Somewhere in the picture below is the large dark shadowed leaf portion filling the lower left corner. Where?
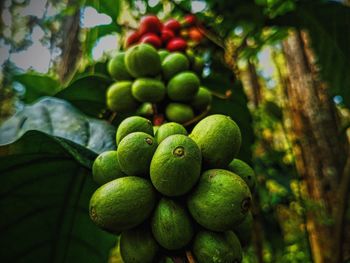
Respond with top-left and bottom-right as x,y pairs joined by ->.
0,131 -> 115,263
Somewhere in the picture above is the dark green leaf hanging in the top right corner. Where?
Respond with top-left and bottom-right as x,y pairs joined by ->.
272,1 -> 350,108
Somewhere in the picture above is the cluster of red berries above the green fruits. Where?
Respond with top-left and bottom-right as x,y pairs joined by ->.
125,15 -> 202,52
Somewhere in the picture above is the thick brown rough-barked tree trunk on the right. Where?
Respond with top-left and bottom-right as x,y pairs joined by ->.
283,31 -> 348,263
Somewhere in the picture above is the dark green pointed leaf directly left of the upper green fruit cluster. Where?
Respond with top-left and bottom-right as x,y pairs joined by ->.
55,74 -> 112,117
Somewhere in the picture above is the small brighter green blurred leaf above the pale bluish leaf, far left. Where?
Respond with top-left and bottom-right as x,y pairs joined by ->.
13,73 -> 61,103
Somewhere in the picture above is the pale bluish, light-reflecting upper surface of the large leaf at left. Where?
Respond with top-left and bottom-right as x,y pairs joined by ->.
0,97 -> 115,153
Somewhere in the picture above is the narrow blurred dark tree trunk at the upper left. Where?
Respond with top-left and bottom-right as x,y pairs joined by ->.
57,0 -> 81,83
